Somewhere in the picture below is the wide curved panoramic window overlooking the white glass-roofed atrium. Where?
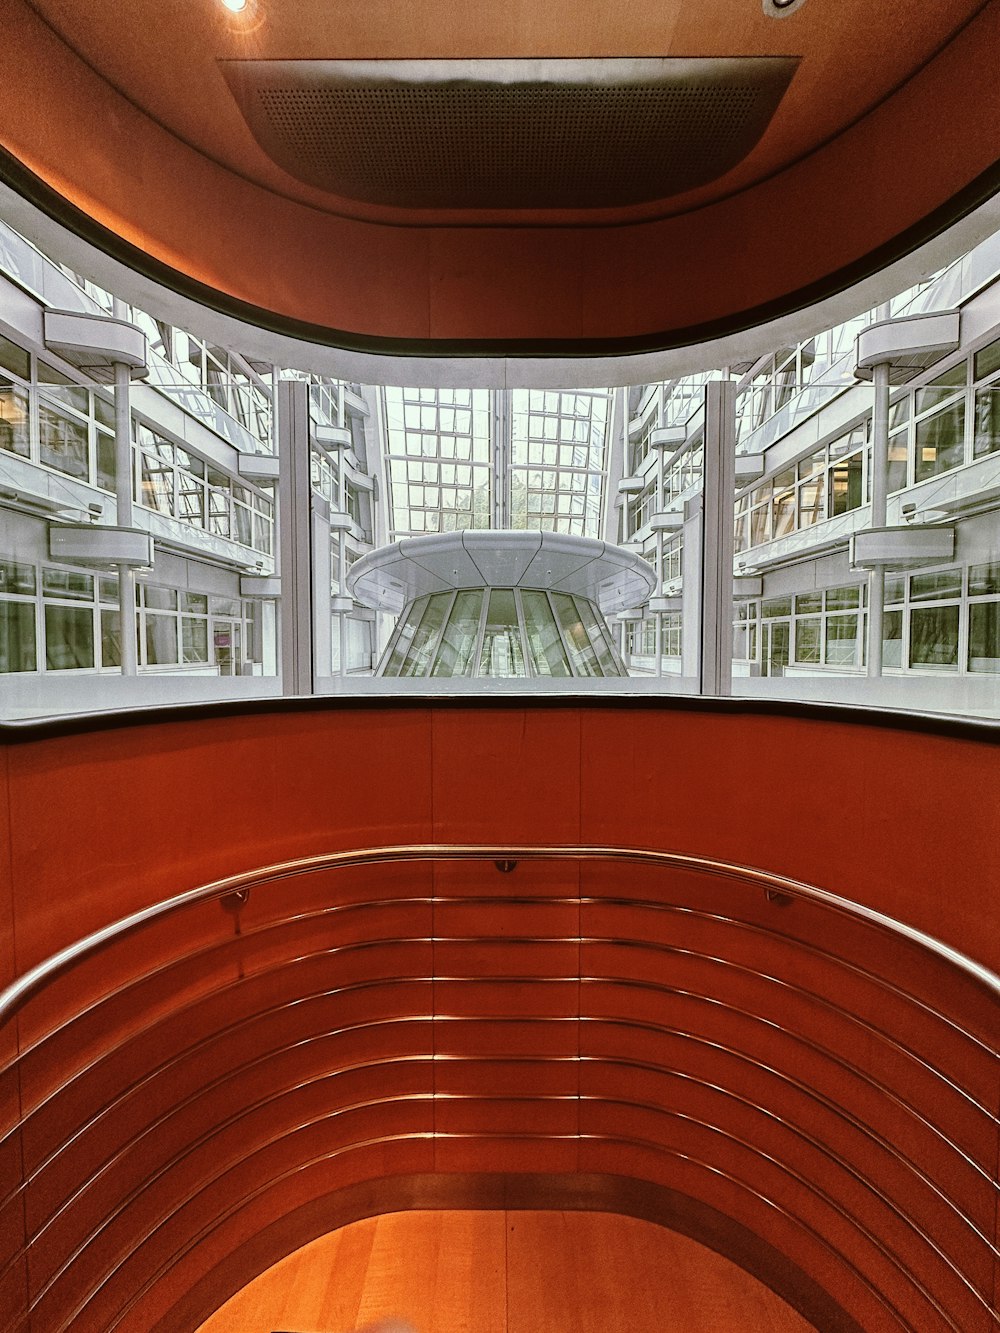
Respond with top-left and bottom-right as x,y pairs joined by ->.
0,210 -> 1000,717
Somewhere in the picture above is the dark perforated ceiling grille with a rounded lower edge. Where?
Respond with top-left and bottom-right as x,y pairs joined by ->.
224,57 -> 796,208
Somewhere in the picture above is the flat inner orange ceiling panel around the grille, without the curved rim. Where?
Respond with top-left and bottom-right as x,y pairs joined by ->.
19,0 -> 983,221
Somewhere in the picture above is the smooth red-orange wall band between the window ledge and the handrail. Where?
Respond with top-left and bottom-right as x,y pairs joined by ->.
5,705 -> 1000,970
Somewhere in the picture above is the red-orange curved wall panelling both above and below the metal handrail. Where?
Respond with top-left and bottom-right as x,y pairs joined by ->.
0,708 -> 1000,1333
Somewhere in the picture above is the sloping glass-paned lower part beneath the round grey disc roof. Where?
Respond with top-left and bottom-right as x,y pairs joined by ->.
376,588 -> 628,680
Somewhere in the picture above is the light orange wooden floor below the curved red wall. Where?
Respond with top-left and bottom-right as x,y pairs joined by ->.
200,1212 -> 812,1333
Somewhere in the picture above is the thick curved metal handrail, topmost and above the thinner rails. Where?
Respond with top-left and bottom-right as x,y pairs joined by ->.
0,842 -> 1000,1026
